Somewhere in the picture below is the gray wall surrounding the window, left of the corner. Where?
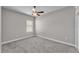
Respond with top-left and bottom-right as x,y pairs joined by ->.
2,8 -> 34,41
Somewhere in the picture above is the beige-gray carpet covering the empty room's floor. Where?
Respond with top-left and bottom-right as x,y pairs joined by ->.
2,37 -> 78,53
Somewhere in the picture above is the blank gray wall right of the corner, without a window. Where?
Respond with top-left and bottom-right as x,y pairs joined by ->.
36,7 -> 75,44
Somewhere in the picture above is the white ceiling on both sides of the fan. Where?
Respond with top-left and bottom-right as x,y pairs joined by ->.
4,6 -> 67,15
